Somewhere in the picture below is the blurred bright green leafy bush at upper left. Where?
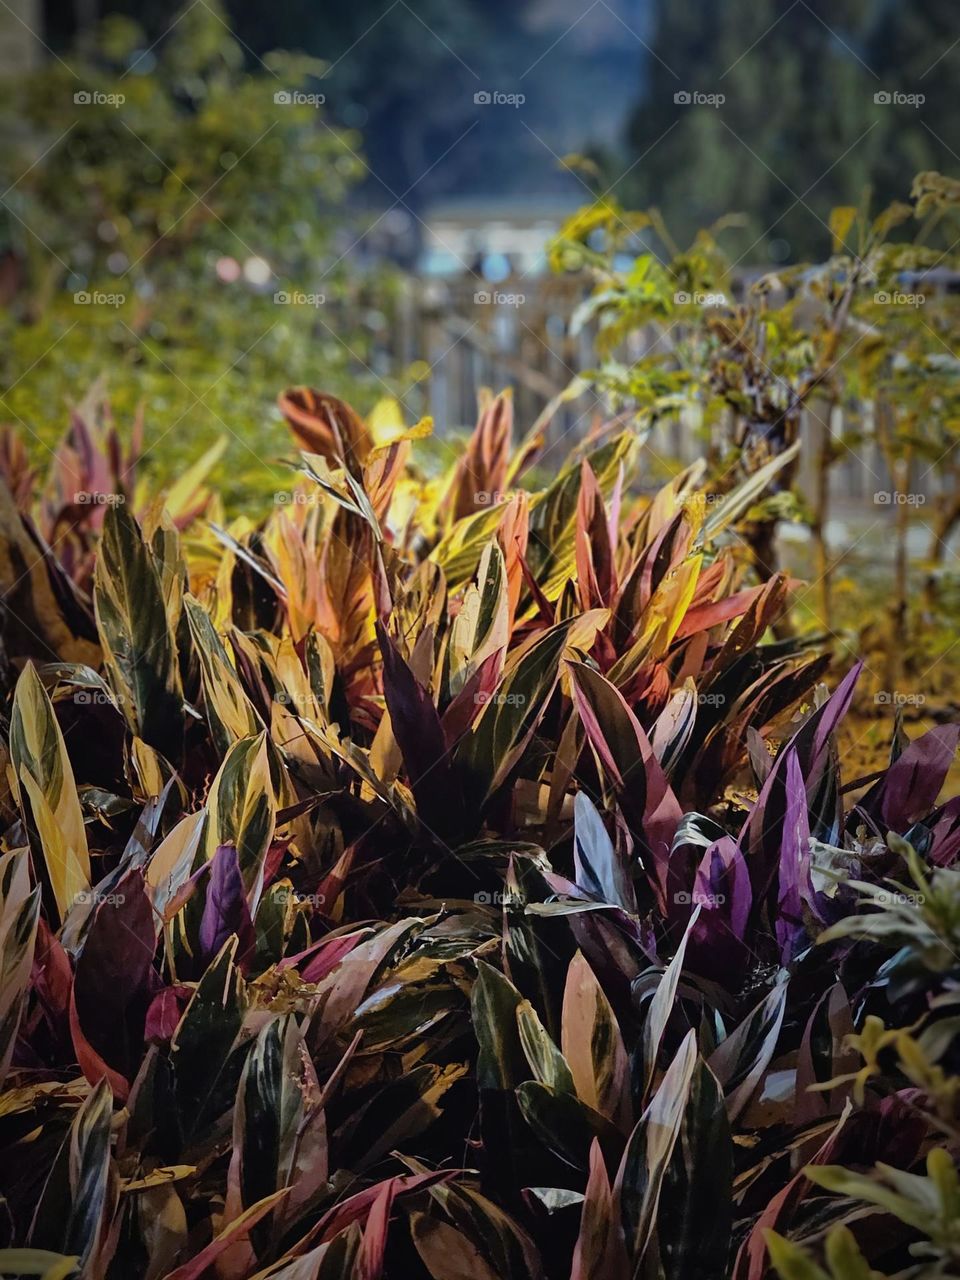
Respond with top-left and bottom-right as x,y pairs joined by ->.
0,3 -> 384,506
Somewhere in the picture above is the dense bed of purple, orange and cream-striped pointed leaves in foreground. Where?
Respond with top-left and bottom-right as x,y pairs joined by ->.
0,388 -> 960,1280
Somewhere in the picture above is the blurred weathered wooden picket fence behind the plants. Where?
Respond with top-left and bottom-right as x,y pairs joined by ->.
355,276 -> 952,515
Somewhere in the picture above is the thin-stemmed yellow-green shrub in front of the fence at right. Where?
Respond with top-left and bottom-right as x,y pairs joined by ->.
552,173 -> 960,687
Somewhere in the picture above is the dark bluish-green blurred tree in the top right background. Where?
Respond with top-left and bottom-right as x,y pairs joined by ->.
619,0 -> 960,264
